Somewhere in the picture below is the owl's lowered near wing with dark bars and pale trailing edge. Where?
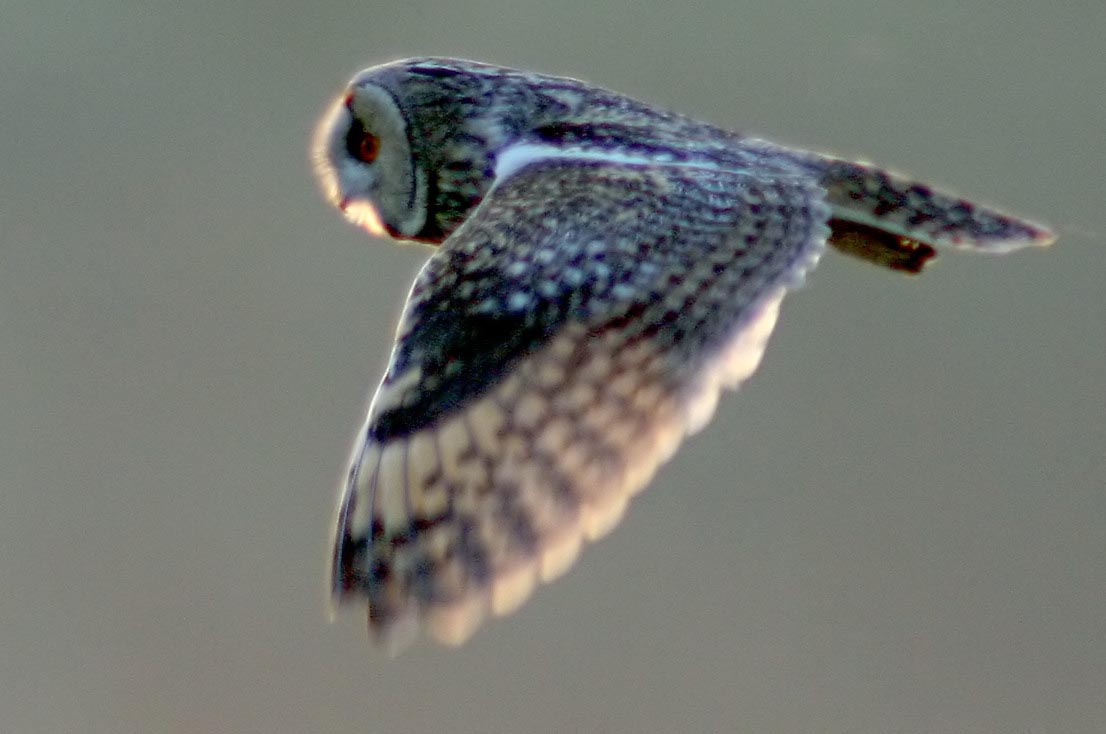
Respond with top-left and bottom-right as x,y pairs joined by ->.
333,159 -> 830,646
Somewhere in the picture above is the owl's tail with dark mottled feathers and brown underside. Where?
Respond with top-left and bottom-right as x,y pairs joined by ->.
803,157 -> 1056,273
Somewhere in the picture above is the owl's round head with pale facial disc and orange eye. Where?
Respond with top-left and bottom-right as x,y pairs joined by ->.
314,59 -> 557,242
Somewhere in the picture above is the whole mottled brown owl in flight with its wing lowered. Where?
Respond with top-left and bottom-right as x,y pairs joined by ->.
314,57 -> 1053,649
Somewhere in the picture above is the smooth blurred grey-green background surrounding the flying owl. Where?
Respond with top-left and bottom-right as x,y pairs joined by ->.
0,0 -> 1106,734
